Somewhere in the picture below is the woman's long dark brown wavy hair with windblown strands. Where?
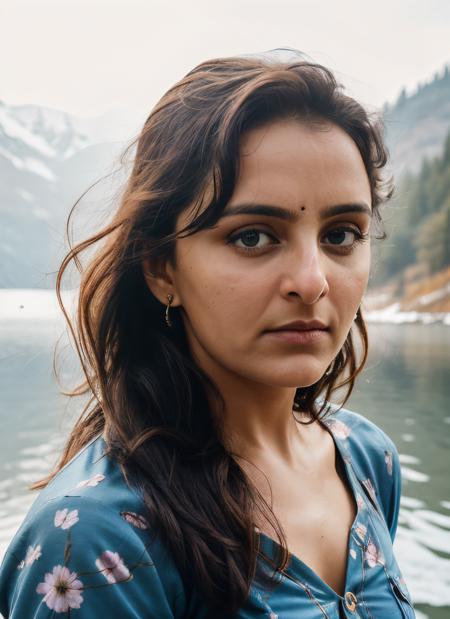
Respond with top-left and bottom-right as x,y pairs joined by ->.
33,51 -> 392,617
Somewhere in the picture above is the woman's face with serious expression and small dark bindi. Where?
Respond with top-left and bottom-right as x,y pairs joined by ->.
163,119 -> 371,387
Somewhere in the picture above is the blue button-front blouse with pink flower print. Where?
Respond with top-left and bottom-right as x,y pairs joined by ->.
0,409 -> 415,619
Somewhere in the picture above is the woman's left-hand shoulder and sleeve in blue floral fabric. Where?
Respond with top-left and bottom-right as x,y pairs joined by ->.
0,437 -> 192,619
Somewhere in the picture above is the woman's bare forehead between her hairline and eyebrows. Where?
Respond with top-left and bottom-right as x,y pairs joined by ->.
177,119 -> 371,230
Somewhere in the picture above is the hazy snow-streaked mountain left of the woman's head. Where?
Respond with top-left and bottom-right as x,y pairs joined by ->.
0,102 -> 142,288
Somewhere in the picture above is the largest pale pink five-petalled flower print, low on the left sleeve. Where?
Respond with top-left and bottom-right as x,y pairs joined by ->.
36,565 -> 83,613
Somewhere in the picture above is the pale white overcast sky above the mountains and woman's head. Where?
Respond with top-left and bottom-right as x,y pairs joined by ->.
0,0 -> 450,116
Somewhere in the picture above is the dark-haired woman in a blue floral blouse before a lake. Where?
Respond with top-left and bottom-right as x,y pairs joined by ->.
0,50 -> 414,619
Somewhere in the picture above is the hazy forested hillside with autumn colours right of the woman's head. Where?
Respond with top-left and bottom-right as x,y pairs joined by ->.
366,66 -> 450,313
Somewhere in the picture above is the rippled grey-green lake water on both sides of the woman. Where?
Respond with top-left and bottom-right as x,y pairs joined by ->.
0,319 -> 450,619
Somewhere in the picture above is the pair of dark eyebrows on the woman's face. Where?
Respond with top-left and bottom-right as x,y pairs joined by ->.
222,202 -> 372,223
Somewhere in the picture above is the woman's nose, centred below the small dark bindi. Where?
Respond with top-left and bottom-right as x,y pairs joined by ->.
282,247 -> 329,305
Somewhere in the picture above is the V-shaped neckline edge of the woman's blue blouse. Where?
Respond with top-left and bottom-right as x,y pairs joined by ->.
259,419 -> 363,600
